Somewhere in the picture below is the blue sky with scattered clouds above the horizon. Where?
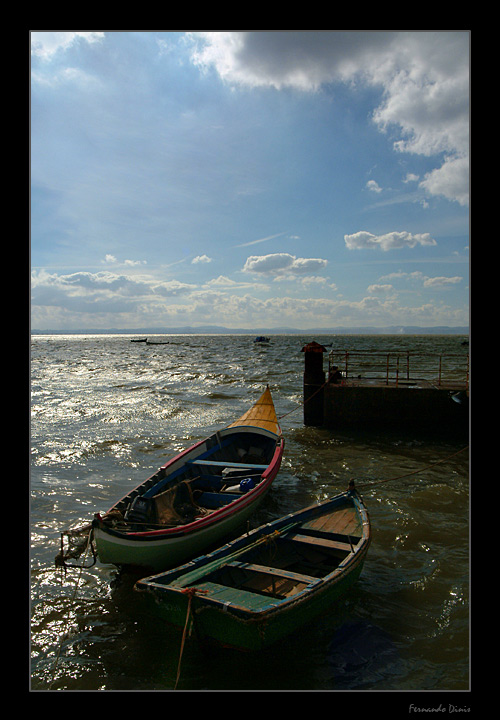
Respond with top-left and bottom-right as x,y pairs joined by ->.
30,30 -> 470,332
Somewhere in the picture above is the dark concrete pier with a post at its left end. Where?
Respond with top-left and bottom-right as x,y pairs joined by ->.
302,342 -> 469,435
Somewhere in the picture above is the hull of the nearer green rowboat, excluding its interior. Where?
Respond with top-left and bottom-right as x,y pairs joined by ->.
135,493 -> 370,651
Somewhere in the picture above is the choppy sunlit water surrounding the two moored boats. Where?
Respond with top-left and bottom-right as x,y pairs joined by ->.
31,335 -> 469,702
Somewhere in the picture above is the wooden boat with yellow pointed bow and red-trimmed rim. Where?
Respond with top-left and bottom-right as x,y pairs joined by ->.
56,387 -> 284,572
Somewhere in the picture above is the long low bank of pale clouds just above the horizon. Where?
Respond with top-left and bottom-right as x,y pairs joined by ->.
32,270 -> 468,330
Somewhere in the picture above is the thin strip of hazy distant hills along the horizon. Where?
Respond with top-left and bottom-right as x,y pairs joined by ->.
31,325 -> 469,335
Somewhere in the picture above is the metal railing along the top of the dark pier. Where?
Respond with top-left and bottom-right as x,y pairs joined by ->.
329,350 -> 469,389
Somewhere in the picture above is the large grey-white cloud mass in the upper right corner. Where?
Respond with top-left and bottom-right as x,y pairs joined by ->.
187,30 -> 469,205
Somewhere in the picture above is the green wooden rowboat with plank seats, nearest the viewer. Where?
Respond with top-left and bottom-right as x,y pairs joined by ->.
135,486 -> 371,650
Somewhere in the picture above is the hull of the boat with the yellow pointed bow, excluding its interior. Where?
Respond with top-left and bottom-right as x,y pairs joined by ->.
87,388 -> 284,572
